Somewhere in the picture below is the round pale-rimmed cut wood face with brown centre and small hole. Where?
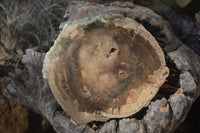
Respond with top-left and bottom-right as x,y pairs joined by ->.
43,16 -> 169,123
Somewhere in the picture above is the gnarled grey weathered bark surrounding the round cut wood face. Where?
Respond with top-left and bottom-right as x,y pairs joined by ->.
0,2 -> 200,133
